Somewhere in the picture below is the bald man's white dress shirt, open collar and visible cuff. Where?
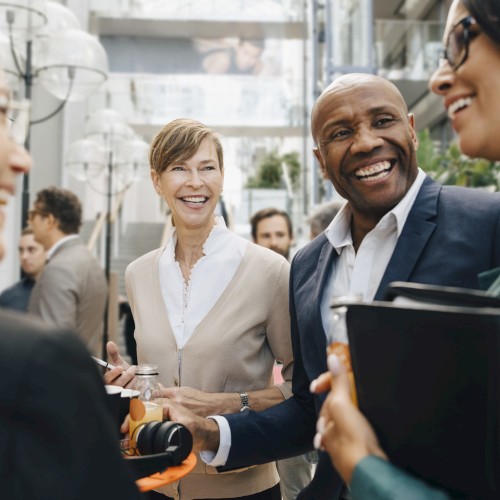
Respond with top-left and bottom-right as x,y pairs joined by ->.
204,168 -> 425,467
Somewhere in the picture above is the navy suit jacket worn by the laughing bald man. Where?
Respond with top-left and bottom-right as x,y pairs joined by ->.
221,177 -> 500,500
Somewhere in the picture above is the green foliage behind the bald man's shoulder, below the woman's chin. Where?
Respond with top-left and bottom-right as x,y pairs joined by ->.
417,129 -> 500,191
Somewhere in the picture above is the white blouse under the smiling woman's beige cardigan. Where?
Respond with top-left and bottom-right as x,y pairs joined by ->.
159,216 -> 248,349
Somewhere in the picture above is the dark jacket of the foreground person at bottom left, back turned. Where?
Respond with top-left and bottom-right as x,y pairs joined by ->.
0,310 -> 142,500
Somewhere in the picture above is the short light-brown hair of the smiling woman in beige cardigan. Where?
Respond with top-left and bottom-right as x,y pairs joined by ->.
149,118 -> 224,174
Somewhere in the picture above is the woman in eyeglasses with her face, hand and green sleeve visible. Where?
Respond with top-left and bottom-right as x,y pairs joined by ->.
311,0 -> 500,500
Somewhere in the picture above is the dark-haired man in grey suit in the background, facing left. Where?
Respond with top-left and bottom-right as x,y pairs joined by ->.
28,187 -> 107,356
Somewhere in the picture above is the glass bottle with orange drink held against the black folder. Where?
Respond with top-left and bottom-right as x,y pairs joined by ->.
326,294 -> 363,406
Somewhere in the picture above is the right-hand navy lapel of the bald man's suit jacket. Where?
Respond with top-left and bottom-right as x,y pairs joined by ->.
375,177 -> 442,300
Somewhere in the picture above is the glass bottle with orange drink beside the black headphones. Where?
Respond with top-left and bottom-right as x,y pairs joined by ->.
130,365 -> 163,448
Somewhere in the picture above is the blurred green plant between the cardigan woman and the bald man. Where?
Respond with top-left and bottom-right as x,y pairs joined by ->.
247,151 -> 300,189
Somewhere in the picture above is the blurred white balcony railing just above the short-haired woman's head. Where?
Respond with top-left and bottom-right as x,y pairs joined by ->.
88,73 -> 303,127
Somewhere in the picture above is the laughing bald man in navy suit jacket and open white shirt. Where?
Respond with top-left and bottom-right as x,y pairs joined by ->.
118,74 -> 500,500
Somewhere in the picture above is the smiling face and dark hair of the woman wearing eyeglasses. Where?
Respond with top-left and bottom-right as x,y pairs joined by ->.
430,0 -> 500,161
